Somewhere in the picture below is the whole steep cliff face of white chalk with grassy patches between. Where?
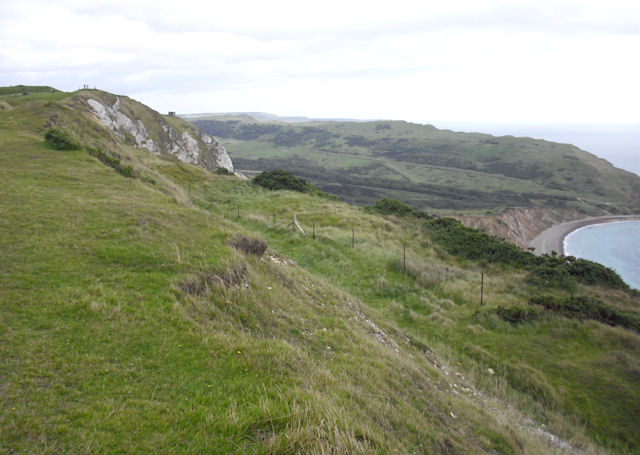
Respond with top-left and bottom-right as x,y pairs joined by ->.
86,94 -> 233,172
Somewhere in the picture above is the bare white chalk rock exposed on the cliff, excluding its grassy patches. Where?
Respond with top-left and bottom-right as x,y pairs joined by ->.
87,97 -> 233,172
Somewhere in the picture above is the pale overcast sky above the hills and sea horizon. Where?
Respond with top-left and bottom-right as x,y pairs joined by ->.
0,0 -> 640,123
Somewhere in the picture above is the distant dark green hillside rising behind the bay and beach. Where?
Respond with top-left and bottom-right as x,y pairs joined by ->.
194,116 -> 640,214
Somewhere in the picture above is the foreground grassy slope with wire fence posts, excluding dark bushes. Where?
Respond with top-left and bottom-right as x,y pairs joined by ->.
0,87 -> 640,453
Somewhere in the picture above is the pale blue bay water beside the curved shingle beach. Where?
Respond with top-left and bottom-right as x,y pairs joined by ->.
564,221 -> 640,289
